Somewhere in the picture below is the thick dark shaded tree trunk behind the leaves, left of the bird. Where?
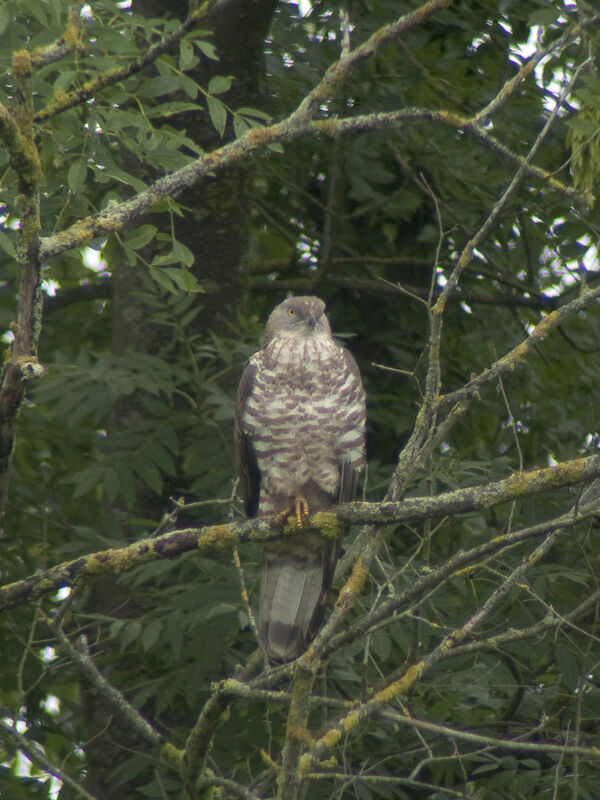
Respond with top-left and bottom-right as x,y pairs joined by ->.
81,0 -> 276,800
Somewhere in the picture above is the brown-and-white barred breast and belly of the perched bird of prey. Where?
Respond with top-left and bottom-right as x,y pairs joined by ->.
242,337 -> 365,514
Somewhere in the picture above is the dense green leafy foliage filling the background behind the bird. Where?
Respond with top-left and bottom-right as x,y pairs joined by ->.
0,0 -> 600,800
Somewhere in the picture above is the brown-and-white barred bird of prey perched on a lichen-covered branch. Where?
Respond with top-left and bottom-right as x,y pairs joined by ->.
235,297 -> 365,663
